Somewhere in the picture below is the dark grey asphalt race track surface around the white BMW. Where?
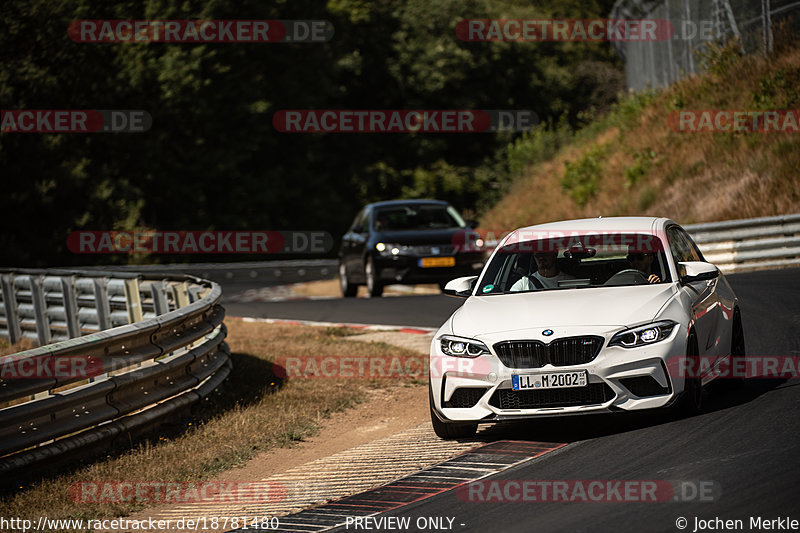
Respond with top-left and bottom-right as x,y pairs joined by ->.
228,269 -> 800,532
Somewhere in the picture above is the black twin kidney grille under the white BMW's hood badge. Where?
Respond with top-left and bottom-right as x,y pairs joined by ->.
494,336 -> 603,368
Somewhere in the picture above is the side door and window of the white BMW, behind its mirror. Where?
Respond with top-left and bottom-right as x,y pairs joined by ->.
667,226 -> 720,364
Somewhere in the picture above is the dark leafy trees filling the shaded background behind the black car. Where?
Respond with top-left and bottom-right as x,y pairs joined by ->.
0,0 -> 621,266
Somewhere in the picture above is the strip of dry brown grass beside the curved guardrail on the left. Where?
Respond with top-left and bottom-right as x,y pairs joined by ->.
0,319 -> 422,519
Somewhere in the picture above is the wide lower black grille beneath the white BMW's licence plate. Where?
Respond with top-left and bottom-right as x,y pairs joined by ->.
489,383 -> 614,409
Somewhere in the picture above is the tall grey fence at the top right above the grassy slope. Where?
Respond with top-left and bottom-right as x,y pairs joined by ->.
610,0 -> 800,91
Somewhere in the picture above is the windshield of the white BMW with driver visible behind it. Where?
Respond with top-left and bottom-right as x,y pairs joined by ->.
477,233 -> 670,295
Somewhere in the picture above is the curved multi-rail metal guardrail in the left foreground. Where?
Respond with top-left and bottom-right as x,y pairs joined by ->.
0,270 -> 232,474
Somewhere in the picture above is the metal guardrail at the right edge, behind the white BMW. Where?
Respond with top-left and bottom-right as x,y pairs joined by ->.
684,214 -> 800,272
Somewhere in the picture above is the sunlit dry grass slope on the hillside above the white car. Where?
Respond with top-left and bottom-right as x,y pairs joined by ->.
481,42 -> 800,232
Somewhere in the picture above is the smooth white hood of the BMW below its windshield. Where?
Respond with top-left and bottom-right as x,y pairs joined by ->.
451,284 -> 675,337
